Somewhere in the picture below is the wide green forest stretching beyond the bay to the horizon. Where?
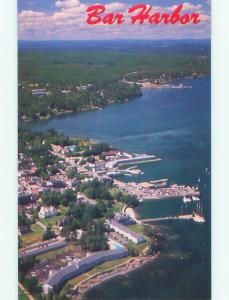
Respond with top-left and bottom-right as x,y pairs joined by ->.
18,45 -> 210,120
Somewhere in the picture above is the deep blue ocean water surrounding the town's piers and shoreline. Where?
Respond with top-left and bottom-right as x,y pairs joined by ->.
29,78 -> 211,299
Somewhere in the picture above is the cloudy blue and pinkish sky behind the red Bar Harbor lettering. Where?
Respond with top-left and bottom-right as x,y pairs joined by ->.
18,0 -> 211,40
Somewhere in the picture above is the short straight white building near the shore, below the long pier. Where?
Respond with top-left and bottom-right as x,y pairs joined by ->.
108,219 -> 145,244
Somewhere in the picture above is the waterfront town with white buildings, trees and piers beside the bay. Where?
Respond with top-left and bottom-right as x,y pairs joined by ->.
18,129 -> 204,299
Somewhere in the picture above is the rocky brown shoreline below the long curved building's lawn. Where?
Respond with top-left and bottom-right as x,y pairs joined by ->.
73,254 -> 159,300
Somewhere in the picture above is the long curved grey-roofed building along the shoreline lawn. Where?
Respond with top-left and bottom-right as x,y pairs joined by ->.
43,247 -> 128,294
